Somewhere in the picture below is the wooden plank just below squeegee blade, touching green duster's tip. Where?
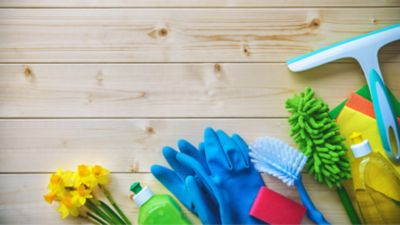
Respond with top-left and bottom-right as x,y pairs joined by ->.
0,63 -> 400,118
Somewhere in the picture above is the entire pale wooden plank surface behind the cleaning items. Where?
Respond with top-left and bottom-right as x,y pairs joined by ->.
0,0 -> 400,224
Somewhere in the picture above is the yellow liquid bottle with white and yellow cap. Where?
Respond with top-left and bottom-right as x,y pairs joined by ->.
351,132 -> 400,224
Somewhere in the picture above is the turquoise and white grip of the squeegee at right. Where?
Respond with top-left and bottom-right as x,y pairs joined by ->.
367,69 -> 400,163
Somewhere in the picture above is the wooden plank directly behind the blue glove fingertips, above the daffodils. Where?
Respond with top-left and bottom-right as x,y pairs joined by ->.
0,119 -> 291,173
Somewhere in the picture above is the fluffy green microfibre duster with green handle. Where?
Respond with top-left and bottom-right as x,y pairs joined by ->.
286,88 -> 361,224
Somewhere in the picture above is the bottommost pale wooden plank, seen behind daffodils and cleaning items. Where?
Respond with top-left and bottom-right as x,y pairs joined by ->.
0,174 -> 350,224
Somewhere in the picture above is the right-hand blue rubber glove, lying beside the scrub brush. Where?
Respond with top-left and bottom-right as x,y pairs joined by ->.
176,128 -> 264,224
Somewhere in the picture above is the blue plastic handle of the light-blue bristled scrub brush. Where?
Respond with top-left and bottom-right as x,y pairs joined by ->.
294,176 -> 330,225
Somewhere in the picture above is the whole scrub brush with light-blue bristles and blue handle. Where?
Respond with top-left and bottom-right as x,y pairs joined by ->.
249,137 -> 329,224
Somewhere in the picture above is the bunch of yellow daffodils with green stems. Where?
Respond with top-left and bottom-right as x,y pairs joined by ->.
43,165 -> 132,225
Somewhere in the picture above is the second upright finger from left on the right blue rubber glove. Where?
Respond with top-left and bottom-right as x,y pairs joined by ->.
217,130 -> 247,170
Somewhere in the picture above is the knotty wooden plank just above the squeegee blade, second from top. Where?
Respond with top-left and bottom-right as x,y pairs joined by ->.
0,7 -> 400,63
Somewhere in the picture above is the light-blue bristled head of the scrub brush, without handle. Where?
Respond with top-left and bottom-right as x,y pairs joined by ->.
249,137 -> 307,186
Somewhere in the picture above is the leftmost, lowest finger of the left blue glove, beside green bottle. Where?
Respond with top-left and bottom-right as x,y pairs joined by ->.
150,165 -> 194,211
